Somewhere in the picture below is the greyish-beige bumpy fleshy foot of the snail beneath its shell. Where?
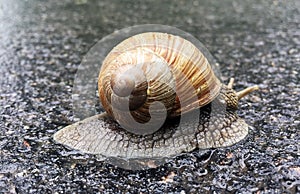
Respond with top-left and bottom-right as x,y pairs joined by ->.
54,86 -> 248,159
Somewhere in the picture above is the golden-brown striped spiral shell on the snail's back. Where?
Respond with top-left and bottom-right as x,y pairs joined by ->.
98,32 -> 221,133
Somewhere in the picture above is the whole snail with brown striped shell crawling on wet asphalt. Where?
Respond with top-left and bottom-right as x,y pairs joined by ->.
54,32 -> 258,169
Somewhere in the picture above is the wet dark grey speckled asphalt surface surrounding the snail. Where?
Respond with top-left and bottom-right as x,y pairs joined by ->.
0,0 -> 300,193
